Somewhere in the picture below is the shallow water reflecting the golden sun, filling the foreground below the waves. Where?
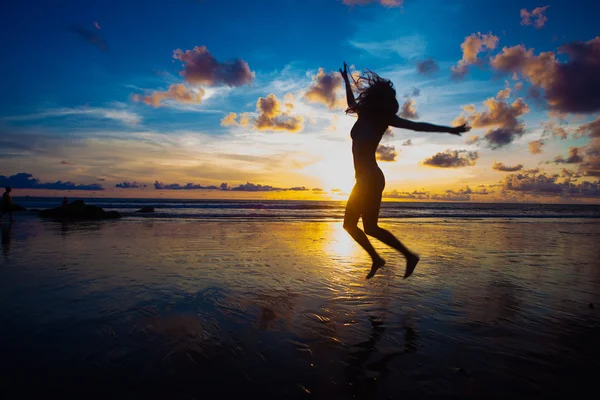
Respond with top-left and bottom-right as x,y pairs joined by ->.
0,218 -> 600,399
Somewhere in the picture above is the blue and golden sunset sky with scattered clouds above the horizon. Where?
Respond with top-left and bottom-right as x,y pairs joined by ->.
0,0 -> 600,203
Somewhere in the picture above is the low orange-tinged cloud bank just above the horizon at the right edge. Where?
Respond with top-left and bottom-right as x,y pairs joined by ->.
501,172 -> 600,198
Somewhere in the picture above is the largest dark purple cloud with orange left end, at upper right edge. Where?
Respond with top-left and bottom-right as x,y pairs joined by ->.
491,37 -> 600,113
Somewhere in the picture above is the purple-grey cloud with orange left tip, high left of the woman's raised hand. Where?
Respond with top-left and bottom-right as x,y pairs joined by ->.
173,46 -> 255,87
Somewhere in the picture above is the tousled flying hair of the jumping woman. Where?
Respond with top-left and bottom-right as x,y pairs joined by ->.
346,69 -> 400,115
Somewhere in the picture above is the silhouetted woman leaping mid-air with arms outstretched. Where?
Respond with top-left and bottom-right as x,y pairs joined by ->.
340,62 -> 471,279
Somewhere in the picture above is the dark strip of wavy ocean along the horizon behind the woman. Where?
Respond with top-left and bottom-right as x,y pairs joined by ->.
14,197 -> 600,220
